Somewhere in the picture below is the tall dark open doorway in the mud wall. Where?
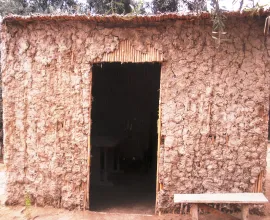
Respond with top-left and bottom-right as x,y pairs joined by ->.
89,63 -> 161,214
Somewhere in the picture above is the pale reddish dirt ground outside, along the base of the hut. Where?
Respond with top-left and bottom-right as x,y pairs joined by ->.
0,144 -> 270,220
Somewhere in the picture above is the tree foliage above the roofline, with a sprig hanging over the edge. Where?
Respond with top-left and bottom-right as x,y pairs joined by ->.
0,0 -> 269,16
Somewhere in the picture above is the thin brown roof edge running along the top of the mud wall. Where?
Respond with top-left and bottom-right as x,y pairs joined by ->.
3,10 -> 270,24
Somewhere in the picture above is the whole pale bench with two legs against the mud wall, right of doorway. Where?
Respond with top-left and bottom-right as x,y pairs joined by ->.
174,193 -> 268,220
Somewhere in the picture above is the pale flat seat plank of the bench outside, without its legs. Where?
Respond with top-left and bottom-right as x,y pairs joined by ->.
174,193 -> 268,204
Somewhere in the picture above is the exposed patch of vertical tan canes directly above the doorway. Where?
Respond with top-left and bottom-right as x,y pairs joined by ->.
94,40 -> 163,63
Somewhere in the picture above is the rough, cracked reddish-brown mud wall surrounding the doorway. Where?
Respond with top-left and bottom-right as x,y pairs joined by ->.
1,14 -> 270,212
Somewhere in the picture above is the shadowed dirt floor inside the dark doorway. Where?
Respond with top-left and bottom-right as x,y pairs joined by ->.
90,173 -> 156,215
